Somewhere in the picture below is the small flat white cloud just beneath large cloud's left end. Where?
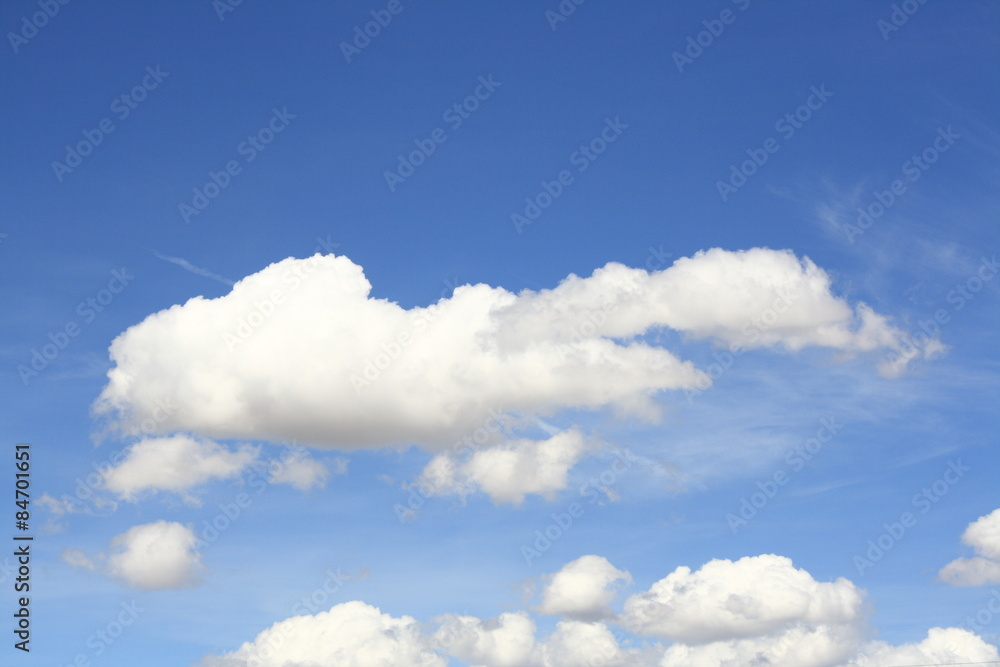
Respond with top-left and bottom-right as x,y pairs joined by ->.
105,435 -> 259,501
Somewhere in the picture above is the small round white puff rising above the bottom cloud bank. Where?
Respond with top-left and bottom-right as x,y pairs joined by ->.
539,556 -> 632,620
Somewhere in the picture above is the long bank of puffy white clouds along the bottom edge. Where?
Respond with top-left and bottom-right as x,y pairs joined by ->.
202,555 -> 998,667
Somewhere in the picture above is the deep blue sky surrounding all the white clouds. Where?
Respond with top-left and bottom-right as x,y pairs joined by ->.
0,0 -> 1000,666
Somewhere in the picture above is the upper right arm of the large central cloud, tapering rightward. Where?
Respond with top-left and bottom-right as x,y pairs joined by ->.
501,248 -> 902,350
